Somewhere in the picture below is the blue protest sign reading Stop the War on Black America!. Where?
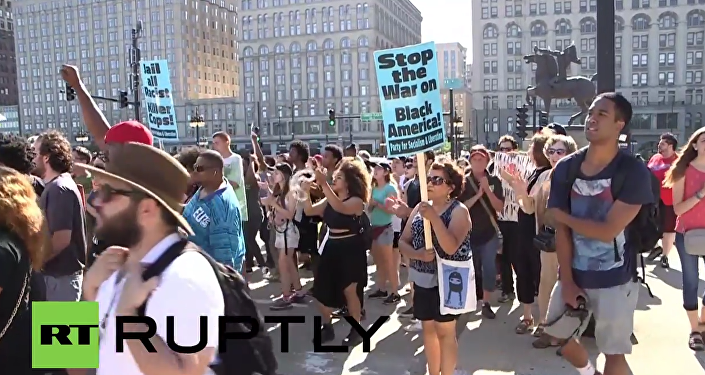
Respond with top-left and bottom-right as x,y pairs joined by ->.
374,42 -> 446,157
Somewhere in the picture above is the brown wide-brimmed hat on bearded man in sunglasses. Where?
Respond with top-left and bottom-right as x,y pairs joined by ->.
76,142 -> 193,235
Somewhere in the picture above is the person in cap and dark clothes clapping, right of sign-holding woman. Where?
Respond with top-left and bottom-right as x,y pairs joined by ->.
458,145 -> 504,319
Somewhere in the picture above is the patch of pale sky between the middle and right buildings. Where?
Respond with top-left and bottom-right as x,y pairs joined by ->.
411,0 -> 479,62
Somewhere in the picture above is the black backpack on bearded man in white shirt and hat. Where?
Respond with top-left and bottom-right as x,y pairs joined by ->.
138,240 -> 277,375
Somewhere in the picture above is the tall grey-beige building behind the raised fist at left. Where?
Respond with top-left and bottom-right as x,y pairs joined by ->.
14,0 -> 240,140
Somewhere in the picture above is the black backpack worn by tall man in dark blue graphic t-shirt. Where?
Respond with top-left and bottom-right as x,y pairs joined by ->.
567,147 -> 663,297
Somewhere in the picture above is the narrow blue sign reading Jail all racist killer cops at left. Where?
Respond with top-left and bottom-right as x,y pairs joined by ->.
140,60 -> 179,141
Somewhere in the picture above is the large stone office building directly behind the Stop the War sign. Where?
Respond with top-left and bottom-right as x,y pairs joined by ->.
239,0 -> 421,153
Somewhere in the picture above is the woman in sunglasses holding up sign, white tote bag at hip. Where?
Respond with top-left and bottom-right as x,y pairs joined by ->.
399,162 -> 475,375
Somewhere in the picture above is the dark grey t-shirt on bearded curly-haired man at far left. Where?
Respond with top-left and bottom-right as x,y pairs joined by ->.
39,173 -> 86,276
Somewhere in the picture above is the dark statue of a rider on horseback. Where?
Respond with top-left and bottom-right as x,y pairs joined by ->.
524,44 -> 597,125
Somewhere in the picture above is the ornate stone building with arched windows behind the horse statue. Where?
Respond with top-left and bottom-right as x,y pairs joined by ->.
472,0 -> 705,149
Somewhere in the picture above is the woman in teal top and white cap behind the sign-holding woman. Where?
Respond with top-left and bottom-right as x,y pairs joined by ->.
367,162 -> 401,305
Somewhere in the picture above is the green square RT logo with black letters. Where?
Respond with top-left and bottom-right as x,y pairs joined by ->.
32,302 -> 100,369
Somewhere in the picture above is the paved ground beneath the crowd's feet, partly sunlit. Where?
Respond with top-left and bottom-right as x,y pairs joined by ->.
251,254 -> 705,375
